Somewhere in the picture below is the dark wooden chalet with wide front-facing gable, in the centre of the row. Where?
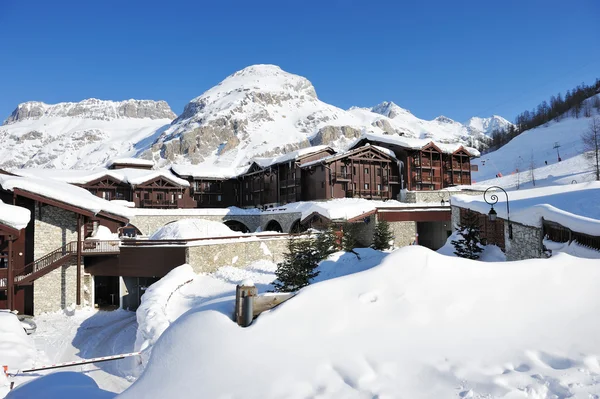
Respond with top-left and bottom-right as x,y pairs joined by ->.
302,144 -> 400,201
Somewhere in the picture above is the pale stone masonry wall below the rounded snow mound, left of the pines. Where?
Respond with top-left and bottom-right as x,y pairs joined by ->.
187,238 -> 288,273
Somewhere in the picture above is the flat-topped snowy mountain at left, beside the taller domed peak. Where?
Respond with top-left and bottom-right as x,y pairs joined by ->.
0,99 -> 176,169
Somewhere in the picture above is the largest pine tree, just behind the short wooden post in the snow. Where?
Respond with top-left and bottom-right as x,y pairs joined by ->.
273,238 -> 321,292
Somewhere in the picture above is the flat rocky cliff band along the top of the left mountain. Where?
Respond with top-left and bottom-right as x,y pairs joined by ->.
4,98 -> 177,125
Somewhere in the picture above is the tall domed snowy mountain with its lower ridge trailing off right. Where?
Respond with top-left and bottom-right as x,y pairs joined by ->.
143,65 -> 508,166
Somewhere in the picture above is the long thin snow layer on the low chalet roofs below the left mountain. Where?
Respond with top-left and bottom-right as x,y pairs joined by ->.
12,168 -> 190,187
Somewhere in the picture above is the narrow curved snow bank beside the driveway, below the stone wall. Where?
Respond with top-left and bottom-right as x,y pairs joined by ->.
135,265 -> 196,370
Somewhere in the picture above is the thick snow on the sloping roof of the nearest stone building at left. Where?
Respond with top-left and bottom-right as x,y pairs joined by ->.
0,174 -> 129,217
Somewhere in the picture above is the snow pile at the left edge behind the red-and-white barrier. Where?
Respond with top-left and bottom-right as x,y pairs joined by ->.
0,310 -> 36,397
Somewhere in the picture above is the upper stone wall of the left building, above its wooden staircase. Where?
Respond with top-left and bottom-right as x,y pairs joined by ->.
33,205 -> 77,259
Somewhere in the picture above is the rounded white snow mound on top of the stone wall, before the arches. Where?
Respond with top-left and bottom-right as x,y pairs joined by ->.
150,219 -> 240,240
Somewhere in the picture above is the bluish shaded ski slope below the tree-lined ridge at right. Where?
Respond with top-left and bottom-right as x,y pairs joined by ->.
472,95 -> 597,188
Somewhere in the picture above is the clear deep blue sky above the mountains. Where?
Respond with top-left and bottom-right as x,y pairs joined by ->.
0,0 -> 600,122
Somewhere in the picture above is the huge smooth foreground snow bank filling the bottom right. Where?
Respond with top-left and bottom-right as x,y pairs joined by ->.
122,246 -> 600,398
